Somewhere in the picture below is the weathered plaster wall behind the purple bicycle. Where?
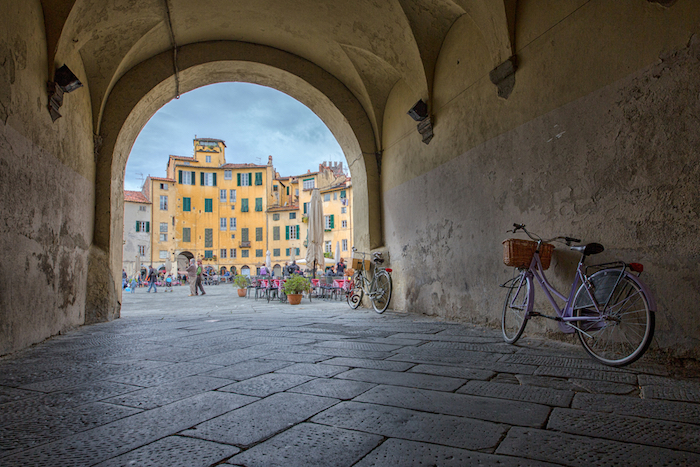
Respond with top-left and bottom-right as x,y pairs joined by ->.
382,1 -> 700,358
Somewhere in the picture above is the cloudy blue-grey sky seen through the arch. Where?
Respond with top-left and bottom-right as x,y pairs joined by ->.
124,83 -> 347,191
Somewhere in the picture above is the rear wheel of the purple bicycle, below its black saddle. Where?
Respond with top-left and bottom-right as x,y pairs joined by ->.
574,270 -> 655,366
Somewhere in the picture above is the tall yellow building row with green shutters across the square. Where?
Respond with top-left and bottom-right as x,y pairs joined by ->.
145,138 -> 352,275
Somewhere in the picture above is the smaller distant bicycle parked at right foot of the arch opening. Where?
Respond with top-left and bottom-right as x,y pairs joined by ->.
346,247 -> 392,313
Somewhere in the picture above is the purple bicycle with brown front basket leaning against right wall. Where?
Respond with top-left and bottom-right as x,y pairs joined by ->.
501,224 -> 656,366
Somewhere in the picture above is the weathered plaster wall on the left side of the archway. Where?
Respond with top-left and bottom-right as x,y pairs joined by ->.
0,1 -> 94,355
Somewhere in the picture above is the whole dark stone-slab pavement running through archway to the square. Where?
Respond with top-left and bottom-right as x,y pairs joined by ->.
0,285 -> 700,467
